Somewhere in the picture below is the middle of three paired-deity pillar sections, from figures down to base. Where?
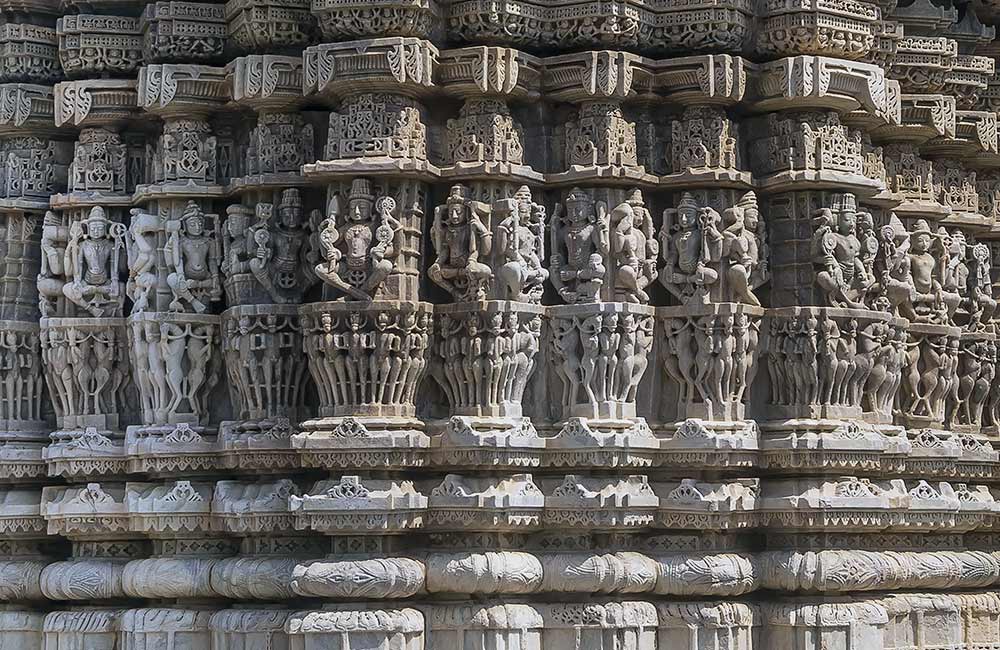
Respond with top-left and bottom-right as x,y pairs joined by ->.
546,188 -> 659,465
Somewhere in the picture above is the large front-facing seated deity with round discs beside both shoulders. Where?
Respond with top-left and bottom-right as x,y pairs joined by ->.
315,178 -> 403,301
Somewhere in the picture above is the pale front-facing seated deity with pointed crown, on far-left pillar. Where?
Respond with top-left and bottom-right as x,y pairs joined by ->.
63,206 -> 125,318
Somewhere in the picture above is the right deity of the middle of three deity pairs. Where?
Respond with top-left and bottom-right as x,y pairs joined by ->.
609,190 -> 660,304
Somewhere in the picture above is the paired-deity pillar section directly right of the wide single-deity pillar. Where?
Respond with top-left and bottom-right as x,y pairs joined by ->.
429,185 -> 548,465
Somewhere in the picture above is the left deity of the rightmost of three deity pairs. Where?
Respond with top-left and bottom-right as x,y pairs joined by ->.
660,192 -> 724,305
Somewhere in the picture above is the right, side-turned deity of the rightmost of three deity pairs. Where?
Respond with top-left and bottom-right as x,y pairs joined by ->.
722,192 -> 768,307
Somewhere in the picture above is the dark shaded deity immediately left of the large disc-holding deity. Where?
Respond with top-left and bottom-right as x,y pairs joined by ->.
247,188 -> 313,304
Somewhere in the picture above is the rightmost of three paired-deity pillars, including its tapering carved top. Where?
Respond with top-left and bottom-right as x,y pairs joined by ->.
653,71 -> 770,454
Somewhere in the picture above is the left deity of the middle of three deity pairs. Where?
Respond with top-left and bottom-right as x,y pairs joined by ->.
549,187 -> 611,304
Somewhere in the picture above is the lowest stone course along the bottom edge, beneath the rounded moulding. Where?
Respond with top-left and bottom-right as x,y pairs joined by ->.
0,591 -> 1000,650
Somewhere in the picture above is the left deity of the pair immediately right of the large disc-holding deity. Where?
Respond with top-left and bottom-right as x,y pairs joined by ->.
427,185 -> 493,301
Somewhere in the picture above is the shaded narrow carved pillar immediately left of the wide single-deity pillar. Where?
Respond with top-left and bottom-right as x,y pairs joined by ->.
219,55 -> 322,469
